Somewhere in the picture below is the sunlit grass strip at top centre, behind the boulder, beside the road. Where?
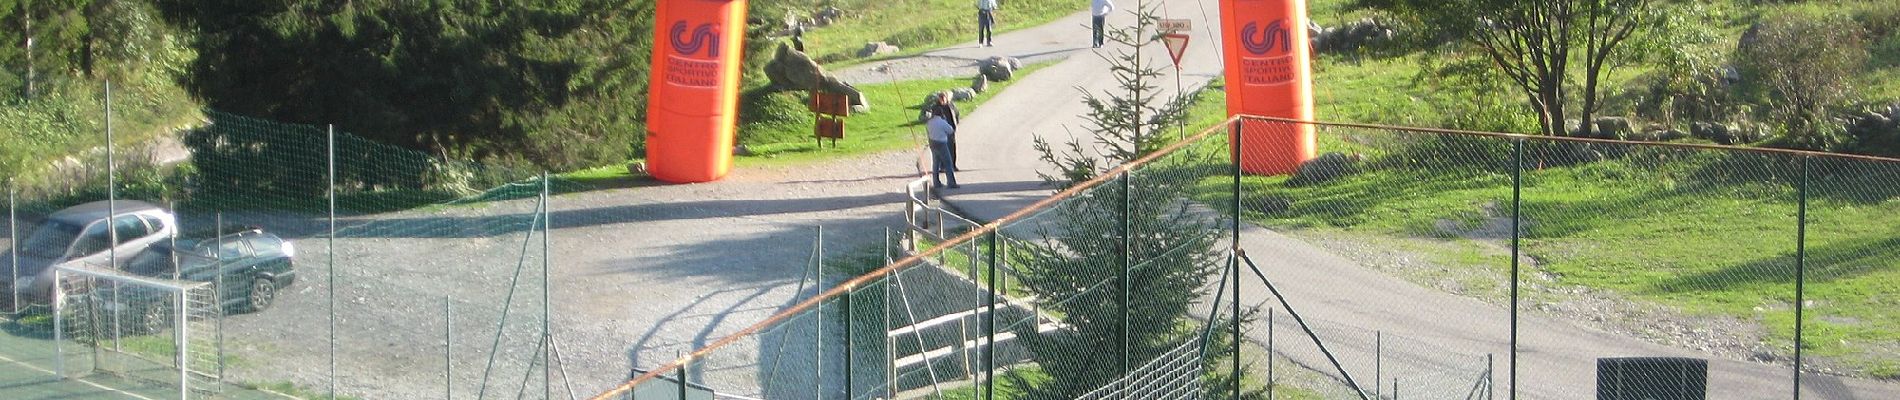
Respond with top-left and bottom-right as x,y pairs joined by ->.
806,0 -> 1094,68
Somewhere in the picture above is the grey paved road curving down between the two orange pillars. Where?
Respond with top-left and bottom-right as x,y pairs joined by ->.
866,0 -> 1900,398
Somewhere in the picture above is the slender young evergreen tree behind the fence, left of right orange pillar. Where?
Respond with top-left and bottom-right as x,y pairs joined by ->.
1018,8 -> 1224,398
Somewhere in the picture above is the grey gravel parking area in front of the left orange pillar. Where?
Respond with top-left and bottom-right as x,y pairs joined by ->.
194,152 -> 916,398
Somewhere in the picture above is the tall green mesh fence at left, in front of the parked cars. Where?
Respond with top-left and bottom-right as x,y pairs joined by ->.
0,82 -> 566,398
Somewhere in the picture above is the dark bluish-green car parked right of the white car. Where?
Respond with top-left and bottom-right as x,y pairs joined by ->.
95,227 -> 296,334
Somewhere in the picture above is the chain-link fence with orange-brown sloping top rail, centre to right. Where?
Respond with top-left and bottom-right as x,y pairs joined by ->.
585,114 -> 1900,398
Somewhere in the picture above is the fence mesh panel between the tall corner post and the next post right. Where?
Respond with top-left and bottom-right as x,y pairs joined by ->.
1239,119 -> 1514,398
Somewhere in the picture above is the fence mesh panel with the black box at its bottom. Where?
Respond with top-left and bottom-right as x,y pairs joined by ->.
1518,140 -> 1799,398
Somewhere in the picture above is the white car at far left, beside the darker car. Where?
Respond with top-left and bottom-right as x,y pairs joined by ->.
0,201 -> 179,303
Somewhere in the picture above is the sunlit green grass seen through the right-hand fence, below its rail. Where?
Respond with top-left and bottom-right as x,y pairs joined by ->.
1203,140 -> 1900,375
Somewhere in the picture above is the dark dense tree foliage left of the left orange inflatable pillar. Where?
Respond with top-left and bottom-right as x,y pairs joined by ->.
158,0 -> 654,169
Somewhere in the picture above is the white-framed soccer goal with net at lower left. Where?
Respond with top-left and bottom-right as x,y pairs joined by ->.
53,265 -> 224,398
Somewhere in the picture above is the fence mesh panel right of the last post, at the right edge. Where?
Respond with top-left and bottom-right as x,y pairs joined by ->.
1782,155 -> 1900,398
